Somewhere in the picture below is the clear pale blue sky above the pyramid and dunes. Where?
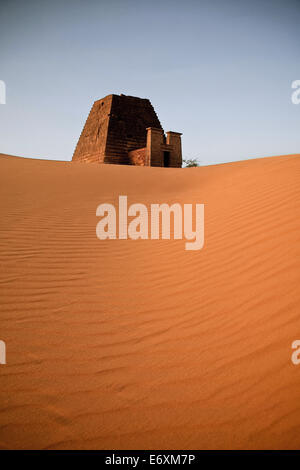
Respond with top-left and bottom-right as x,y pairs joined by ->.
0,0 -> 300,165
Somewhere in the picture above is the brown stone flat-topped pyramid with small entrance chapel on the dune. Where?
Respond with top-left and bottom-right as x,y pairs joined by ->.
72,95 -> 182,168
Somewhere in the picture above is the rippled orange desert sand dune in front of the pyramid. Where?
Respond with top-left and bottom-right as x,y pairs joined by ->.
0,155 -> 300,449
